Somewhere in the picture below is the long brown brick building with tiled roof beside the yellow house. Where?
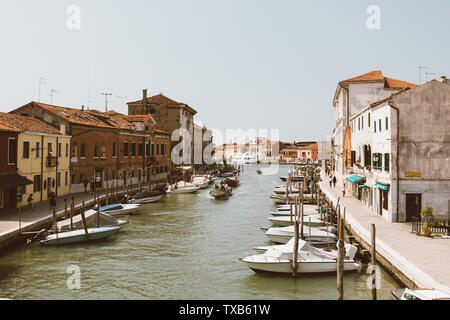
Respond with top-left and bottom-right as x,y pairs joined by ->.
11,102 -> 154,192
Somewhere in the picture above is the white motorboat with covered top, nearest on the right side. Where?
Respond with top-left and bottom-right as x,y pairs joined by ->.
239,239 -> 359,274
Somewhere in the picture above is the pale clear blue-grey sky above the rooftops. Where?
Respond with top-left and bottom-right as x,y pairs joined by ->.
0,0 -> 450,141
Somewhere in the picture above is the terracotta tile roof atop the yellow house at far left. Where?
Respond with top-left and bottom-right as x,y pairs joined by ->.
0,112 -> 60,134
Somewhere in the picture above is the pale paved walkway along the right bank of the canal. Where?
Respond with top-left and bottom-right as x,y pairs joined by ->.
320,176 -> 450,294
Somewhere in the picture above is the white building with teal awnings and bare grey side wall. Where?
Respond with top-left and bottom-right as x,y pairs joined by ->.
346,78 -> 450,222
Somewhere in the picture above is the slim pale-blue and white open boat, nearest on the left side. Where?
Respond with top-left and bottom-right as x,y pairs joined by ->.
40,227 -> 120,246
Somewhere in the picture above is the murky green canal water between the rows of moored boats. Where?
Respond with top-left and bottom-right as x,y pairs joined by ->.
0,166 -> 398,300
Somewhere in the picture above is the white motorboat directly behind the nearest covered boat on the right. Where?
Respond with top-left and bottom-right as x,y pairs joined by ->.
262,226 -> 337,246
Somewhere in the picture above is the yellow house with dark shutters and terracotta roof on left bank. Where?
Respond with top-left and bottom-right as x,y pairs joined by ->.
0,114 -> 71,206
